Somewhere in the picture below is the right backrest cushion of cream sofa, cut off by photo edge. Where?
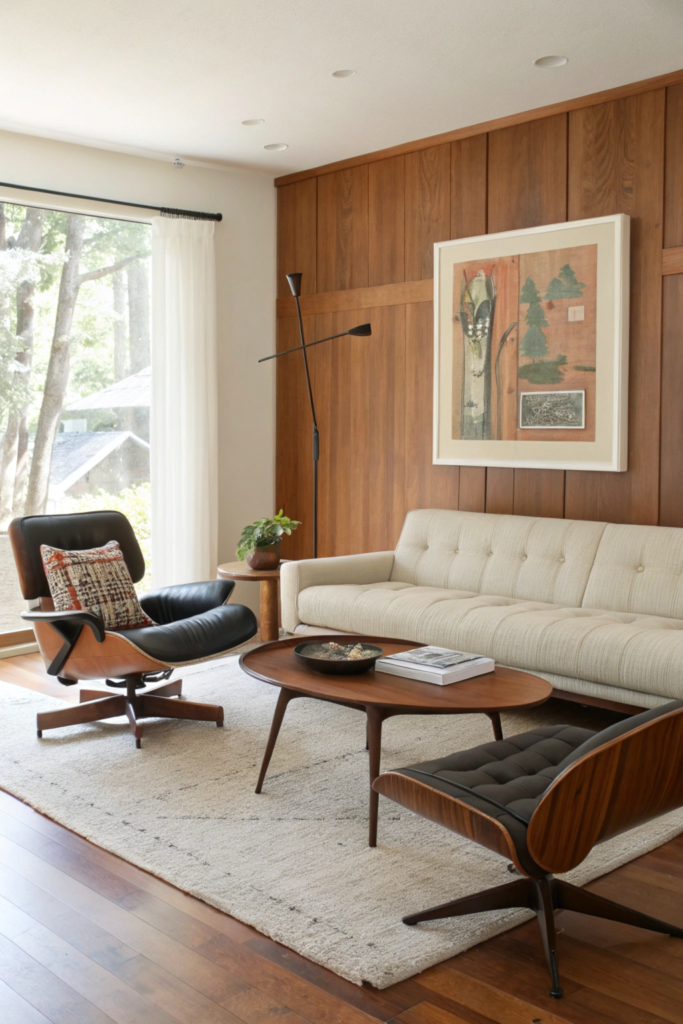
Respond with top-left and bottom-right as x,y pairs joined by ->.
582,523 -> 683,618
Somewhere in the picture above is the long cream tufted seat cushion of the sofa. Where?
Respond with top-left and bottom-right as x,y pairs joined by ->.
298,582 -> 683,702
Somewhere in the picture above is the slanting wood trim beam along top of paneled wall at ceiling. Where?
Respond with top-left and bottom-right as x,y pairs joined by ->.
274,69 -> 683,188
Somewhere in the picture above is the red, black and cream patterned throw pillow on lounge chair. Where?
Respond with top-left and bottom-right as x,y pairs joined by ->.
40,541 -> 156,630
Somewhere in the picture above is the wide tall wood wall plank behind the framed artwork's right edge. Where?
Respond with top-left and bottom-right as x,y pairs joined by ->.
565,89 -> 665,523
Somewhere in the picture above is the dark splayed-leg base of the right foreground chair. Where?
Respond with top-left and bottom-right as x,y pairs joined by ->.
403,874 -> 683,999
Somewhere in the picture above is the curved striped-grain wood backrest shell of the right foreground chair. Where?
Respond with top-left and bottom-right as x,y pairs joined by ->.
526,709 -> 683,874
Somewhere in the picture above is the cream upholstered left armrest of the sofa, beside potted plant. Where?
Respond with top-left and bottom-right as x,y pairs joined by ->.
280,551 -> 393,633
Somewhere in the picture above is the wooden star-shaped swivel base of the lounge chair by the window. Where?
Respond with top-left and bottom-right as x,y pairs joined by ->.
36,672 -> 223,750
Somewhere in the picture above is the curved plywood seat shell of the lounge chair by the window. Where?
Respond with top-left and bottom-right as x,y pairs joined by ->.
33,623 -> 168,680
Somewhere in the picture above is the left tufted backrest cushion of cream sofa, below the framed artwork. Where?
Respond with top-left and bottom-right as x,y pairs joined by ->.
391,509 -> 606,607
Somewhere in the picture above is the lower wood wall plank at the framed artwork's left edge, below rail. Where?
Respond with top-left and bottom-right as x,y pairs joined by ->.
404,302 -> 460,511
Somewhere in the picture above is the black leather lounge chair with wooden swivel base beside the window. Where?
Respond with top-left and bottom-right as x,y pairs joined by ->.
9,512 -> 257,748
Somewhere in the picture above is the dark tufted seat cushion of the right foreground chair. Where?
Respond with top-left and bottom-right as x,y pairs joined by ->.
394,725 -> 597,874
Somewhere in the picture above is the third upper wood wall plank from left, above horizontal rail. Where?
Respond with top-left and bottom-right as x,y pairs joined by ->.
368,157 -> 405,286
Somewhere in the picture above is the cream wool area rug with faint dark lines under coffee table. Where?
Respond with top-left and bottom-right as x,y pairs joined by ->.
0,657 -> 683,988
